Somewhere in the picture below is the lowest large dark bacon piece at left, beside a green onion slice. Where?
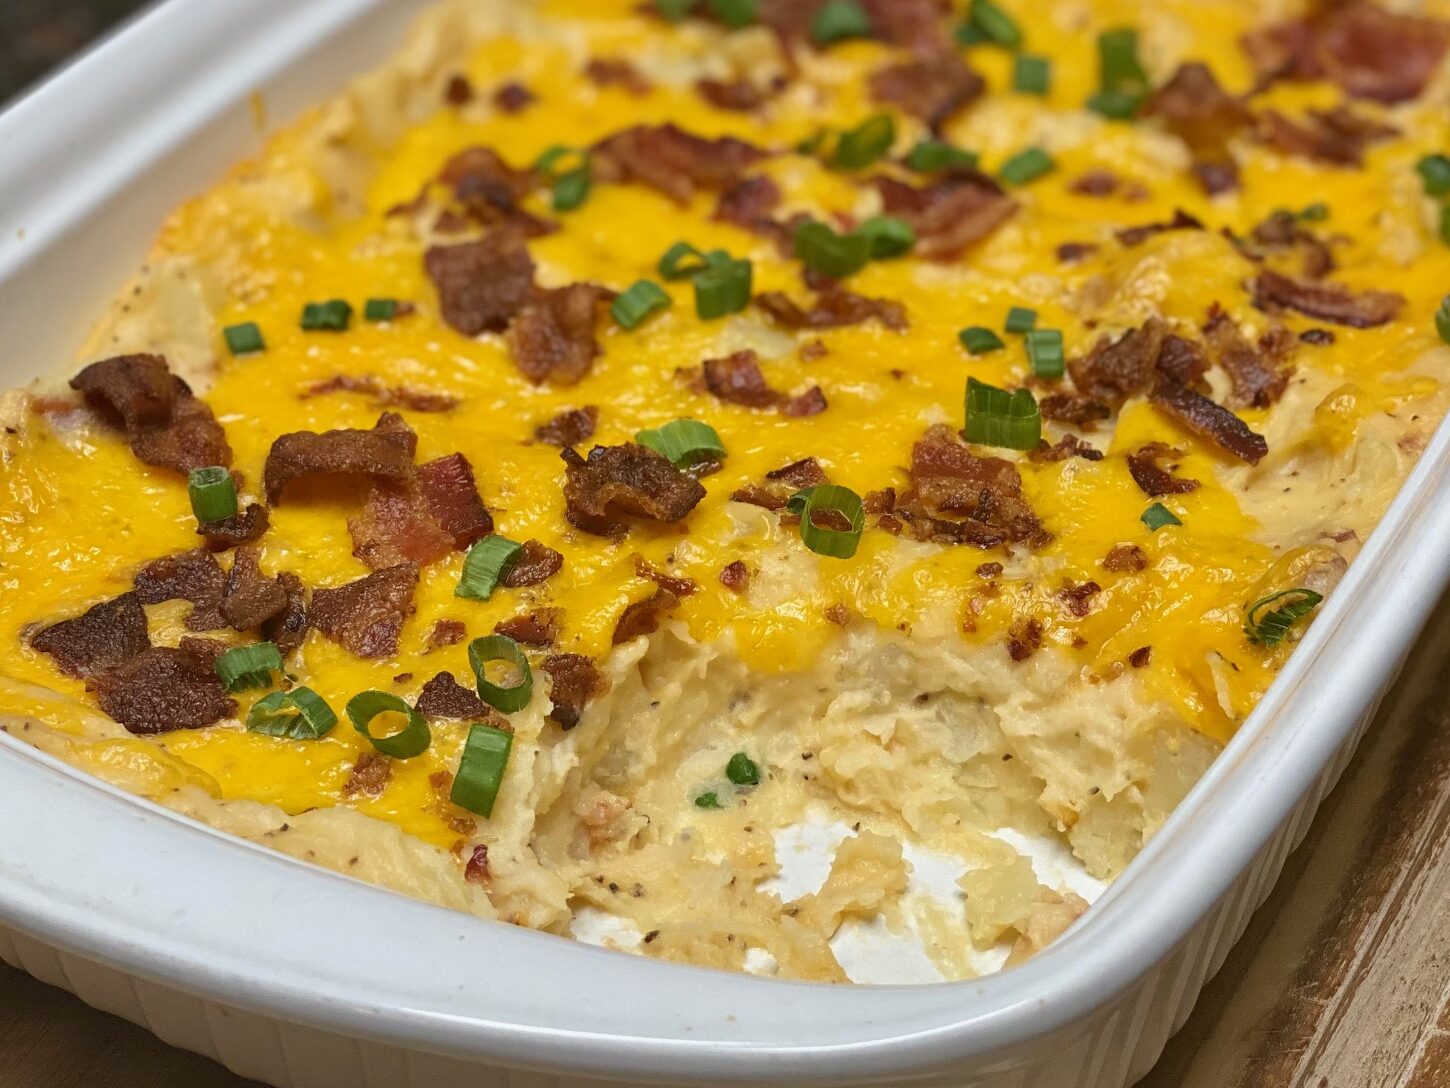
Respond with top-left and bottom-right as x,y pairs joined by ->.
91,647 -> 236,735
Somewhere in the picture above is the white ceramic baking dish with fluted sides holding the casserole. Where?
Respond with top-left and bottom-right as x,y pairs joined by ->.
0,0 -> 1450,1088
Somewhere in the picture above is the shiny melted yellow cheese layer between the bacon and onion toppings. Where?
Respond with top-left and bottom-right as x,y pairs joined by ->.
0,0 -> 1450,846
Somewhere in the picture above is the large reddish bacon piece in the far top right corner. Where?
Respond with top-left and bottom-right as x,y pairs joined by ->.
1243,0 -> 1450,103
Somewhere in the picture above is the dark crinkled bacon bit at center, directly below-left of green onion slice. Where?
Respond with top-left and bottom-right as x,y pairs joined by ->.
563,442 -> 705,537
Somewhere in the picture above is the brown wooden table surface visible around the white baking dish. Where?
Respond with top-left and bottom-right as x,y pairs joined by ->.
8,0 -> 1450,1088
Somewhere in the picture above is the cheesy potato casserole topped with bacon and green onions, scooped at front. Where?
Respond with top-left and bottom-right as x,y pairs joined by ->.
0,0 -> 1450,979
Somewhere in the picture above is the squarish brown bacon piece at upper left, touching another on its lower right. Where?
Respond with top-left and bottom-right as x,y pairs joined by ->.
423,229 -> 534,337
